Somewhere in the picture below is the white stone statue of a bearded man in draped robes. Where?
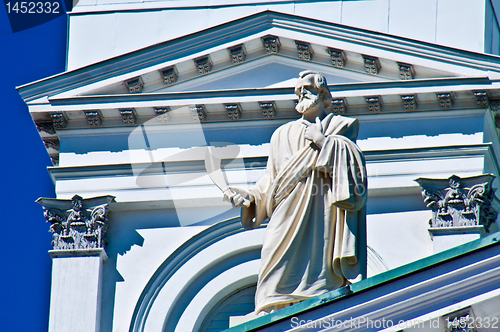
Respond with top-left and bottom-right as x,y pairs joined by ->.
224,71 -> 367,313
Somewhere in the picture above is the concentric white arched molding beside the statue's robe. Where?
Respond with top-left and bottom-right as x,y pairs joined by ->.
129,218 -> 265,332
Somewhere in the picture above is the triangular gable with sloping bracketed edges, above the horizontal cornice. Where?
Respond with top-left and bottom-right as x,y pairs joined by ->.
15,11 -> 500,103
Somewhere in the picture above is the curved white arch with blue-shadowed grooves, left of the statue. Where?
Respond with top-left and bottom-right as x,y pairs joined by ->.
129,217 -> 265,332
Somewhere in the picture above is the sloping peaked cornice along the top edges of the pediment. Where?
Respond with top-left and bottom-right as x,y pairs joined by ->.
18,11 -> 500,102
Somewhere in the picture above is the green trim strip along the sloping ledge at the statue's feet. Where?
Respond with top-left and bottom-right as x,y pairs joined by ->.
226,232 -> 500,332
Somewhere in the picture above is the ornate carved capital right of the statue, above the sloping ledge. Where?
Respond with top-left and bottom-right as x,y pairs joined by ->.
415,174 -> 498,232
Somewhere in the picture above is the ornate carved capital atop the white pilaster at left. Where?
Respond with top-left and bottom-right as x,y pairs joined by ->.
37,195 -> 114,250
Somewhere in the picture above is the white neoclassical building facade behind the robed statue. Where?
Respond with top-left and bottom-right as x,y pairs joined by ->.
19,0 -> 500,331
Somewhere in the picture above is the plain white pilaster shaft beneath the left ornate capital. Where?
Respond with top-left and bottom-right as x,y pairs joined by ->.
49,248 -> 107,332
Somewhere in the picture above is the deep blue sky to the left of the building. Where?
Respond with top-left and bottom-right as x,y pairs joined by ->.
0,6 -> 67,332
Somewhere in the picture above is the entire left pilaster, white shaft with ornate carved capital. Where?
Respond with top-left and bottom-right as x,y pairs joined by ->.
37,195 -> 114,332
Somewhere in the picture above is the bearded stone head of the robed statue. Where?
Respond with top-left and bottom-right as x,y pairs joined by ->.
295,70 -> 332,114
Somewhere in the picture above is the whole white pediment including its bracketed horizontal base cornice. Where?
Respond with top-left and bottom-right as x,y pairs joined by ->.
18,11 -> 500,171
